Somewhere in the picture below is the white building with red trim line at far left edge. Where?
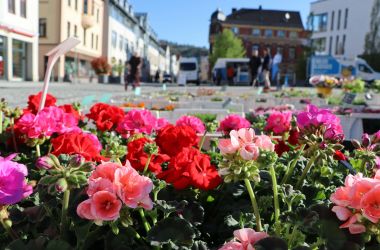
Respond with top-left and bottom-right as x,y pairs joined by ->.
0,0 -> 38,81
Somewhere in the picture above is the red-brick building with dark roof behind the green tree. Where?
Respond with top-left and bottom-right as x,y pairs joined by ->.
209,6 -> 309,74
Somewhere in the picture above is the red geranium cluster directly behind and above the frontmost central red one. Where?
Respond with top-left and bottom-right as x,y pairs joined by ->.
156,124 -> 198,157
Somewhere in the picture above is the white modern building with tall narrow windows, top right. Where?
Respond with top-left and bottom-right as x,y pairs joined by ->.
308,0 -> 375,58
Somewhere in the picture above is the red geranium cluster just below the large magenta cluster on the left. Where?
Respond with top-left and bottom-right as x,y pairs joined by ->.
51,132 -> 103,161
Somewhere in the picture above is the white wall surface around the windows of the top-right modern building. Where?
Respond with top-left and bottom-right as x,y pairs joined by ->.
310,0 -> 374,58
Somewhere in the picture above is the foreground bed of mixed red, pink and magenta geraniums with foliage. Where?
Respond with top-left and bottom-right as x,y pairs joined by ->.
0,89 -> 380,250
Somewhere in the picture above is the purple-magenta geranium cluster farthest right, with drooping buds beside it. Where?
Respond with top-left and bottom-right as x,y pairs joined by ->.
297,105 -> 344,141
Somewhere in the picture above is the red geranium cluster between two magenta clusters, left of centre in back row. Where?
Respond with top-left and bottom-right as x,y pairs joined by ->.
87,103 -> 124,131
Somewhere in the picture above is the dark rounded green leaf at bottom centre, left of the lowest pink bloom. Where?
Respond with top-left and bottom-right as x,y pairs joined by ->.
147,218 -> 195,246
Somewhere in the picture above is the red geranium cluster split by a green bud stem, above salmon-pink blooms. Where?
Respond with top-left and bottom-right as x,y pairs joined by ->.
127,137 -> 170,174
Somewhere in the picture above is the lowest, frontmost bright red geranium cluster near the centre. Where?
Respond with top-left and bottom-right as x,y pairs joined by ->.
157,147 -> 222,190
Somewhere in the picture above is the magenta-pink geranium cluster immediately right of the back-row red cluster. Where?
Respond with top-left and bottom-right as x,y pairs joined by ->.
117,109 -> 157,134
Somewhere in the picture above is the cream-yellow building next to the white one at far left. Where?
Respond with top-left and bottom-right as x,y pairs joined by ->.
39,0 -> 104,80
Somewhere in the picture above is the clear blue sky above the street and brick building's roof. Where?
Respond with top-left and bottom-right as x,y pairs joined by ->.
129,0 -> 315,47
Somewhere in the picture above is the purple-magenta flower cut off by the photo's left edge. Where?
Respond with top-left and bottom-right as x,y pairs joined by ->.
0,154 -> 33,205
